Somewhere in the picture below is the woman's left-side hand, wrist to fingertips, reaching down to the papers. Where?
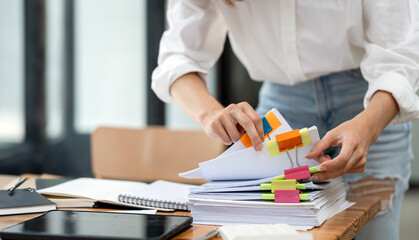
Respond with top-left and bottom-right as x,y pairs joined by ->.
199,102 -> 264,151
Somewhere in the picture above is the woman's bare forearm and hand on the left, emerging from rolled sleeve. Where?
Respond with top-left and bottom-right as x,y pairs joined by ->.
170,73 -> 264,151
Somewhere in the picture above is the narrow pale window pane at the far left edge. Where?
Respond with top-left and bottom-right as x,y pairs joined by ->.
0,0 -> 25,146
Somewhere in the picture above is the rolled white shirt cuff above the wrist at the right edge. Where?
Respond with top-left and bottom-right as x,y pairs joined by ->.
364,72 -> 419,124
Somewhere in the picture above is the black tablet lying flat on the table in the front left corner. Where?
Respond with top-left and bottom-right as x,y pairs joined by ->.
0,210 -> 192,240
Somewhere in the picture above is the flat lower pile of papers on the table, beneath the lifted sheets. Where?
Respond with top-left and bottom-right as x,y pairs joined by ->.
189,178 -> 352,230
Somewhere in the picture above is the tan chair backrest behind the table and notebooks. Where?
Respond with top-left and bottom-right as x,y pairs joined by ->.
91,127 -> 225,184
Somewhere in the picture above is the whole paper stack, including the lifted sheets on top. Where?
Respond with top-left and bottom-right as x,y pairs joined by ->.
179,109 -> 352,230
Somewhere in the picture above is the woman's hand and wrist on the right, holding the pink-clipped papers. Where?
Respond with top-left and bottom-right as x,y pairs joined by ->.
306,91 -> 399,180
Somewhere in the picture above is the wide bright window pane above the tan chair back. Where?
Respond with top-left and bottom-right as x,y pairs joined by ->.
74,0 -> 146,133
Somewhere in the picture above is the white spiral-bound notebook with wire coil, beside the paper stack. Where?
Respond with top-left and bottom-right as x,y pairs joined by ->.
118,180 -> 196,210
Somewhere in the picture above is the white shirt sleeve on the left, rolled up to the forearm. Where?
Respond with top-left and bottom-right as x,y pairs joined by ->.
151,0 -> 227,102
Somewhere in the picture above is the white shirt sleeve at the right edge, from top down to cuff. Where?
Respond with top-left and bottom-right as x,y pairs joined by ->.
361,0 -> 419,123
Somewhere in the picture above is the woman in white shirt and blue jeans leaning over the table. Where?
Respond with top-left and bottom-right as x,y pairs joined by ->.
152,0 -> 419,239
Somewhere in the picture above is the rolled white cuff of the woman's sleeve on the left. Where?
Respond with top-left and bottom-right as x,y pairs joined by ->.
151,58 -> 209,103
